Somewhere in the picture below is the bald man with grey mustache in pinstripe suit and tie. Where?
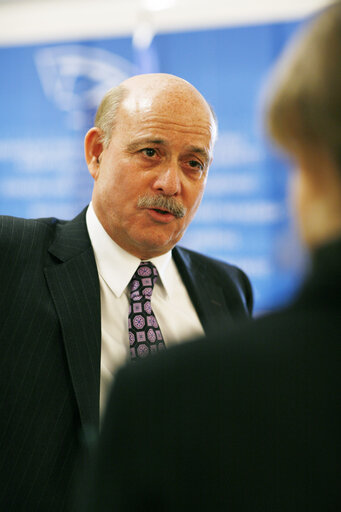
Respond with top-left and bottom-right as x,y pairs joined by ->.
0,74 -> 252,512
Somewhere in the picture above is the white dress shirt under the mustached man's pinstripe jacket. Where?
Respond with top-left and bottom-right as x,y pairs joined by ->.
86,203 -> 204,415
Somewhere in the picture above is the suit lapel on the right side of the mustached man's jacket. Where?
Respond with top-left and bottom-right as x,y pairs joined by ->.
173,247 -> 233,334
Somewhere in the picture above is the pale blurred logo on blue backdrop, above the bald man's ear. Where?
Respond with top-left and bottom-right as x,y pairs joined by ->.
35,45 -> 135,130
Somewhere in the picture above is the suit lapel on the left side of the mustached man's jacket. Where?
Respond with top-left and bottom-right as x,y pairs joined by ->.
44,211 -> 101,427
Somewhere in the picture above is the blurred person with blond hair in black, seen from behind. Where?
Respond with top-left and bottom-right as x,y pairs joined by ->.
79,8 -> 341,512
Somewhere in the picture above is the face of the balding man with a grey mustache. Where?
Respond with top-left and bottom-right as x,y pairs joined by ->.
90,86 -> 212,259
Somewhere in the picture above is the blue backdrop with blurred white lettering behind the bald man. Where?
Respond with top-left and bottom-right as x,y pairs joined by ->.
0,22 -> 301,312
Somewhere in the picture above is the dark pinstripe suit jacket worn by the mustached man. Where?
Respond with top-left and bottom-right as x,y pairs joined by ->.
0,210 -> 252,512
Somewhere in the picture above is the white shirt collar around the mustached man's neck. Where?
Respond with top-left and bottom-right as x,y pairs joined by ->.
86,203 -> 172,297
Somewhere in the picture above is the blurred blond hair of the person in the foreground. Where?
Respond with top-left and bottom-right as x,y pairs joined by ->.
266,1 -> 341,170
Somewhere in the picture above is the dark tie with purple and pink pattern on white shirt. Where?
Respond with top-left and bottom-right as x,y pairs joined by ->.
128,261 -> 165,361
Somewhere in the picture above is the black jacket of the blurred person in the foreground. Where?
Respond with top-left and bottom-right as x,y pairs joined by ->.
87,237 -> 341,512
